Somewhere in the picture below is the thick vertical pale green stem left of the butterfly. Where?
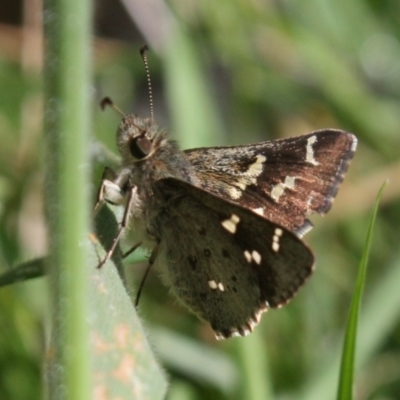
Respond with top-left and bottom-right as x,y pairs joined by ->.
44,0 -> 91,400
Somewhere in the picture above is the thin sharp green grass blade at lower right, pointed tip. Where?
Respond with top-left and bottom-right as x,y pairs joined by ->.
337,182 -> 387,400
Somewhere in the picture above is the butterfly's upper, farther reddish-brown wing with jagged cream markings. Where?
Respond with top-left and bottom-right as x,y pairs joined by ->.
185,130 -> 357,236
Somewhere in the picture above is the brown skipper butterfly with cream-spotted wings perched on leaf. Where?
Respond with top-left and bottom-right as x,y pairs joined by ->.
99,108 -> 357,338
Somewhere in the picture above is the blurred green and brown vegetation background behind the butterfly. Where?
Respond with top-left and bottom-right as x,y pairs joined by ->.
0,0 -> 400,400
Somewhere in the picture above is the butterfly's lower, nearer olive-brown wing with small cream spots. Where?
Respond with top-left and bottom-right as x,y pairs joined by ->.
155,178 -> 314,338
